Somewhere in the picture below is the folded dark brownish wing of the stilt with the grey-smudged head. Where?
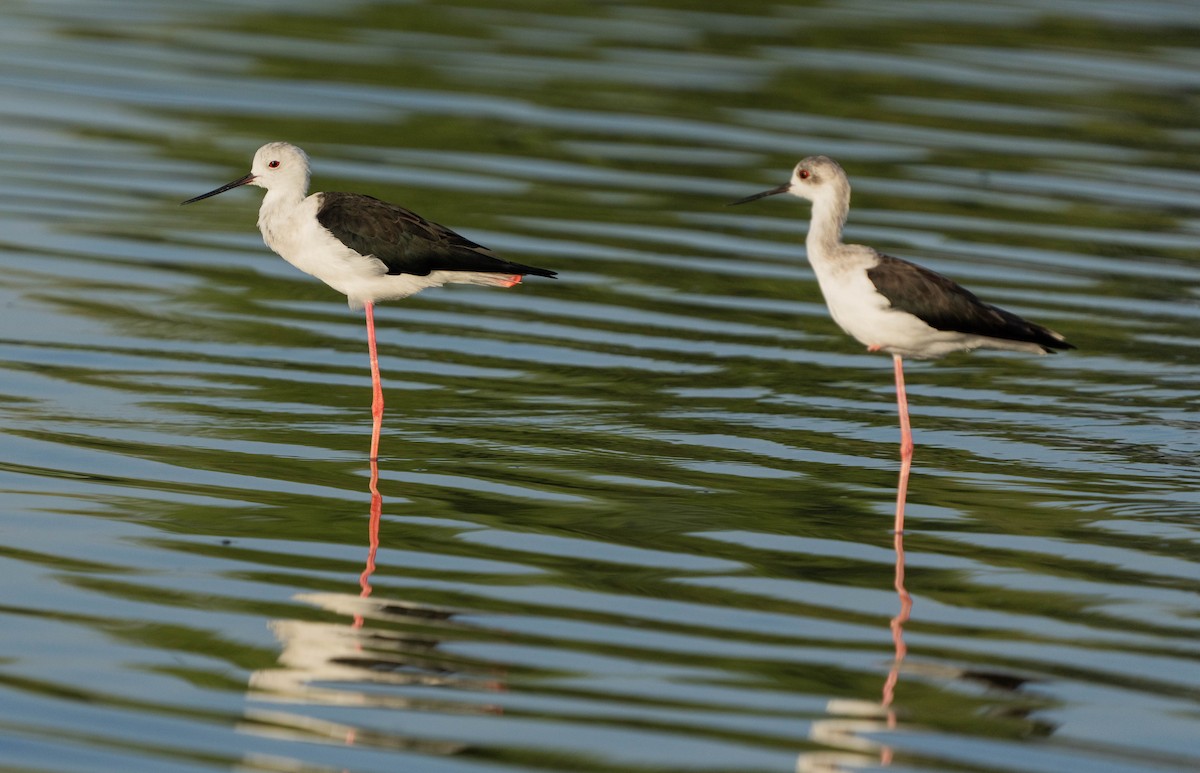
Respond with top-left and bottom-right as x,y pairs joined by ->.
866,254 -> 1075,352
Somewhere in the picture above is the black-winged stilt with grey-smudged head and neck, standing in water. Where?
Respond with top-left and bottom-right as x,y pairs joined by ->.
732,156 -> 1075,533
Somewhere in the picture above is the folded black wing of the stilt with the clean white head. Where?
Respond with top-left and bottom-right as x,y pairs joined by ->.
317,193 -> 556,276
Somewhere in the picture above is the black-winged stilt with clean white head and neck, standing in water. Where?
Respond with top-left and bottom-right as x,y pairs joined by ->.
184,143 -> 556,459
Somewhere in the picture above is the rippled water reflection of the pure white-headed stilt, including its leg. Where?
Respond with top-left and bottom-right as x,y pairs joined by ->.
239,460 -> 504,755
